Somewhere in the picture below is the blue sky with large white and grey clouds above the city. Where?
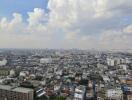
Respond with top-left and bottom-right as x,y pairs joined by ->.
0,0 -> 132,50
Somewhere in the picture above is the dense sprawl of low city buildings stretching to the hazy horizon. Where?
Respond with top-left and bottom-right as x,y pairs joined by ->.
0,49 -> 132,100
